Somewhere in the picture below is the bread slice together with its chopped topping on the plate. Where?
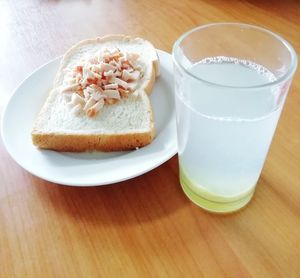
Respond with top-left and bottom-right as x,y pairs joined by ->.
31,35 -> 159,152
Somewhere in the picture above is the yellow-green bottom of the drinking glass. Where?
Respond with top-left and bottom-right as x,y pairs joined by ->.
180,168 -> 255,213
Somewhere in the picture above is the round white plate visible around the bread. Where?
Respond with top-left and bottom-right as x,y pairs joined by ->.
2,50 -> 177,186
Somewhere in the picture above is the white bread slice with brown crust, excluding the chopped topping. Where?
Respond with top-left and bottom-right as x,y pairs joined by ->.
31,35 -> 159,152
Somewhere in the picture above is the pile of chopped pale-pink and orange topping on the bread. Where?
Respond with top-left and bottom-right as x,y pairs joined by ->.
61,49 -> 143,117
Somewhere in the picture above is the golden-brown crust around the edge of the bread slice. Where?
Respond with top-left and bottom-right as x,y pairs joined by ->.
31,35 -> 159,152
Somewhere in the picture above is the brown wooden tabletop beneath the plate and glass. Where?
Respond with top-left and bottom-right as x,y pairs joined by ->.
0,0 -> 300,277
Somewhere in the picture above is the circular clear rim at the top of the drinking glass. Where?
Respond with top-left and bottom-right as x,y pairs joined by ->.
172,22 -> 297,90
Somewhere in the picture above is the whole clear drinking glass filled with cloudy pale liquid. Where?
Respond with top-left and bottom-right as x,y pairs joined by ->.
173,23 -> 297,213
